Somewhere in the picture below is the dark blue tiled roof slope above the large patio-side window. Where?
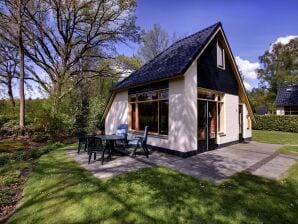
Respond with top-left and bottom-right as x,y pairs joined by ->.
113,22 -> 221,91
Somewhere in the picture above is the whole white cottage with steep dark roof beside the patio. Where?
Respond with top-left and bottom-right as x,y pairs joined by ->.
104,23 -> 255,156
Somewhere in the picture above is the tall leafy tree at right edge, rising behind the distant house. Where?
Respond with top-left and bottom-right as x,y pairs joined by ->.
258,38 -> 298,104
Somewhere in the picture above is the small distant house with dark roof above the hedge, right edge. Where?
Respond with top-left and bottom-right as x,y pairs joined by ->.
275,85 -> 298,115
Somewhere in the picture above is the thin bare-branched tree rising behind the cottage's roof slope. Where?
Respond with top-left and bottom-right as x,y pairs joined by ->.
138,24 -> 171,62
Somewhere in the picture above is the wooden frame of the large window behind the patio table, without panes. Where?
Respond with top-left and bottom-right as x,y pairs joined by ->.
128,88 -> 169,136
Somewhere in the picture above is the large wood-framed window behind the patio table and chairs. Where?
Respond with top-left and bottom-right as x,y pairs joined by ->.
129,89 -> 169,135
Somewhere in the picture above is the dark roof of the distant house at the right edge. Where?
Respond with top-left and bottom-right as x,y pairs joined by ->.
275,85 -> 298,106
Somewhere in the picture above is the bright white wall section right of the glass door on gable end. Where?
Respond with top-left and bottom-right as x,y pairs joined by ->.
217,93 -> 239,145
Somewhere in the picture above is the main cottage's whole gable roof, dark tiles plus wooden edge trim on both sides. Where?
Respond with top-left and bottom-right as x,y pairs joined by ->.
102,22 -> 256,123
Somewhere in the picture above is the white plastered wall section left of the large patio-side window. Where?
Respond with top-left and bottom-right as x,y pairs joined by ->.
105,91 -> 128,135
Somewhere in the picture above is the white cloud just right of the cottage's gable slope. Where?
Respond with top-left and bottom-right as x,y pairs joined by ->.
235,56 -> 261,80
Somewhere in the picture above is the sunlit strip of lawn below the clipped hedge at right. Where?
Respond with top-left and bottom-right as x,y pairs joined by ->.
252,130 -> 298,145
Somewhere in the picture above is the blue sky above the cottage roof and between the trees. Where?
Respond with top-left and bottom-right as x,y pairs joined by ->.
118,0 -> 298,90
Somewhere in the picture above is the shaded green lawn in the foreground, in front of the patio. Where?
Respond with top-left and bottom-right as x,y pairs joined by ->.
8,146 -> 298,223
